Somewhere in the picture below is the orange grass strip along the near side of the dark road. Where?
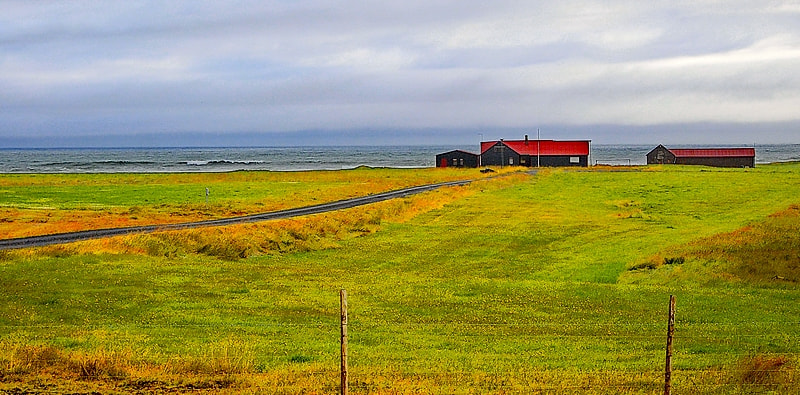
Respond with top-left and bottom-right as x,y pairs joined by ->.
6,173 -> 510,260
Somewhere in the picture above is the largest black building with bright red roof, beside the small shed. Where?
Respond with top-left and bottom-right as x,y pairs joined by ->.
481,136 -> 591,167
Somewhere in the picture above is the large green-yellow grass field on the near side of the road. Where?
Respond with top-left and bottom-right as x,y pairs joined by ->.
0,164 -> 800,393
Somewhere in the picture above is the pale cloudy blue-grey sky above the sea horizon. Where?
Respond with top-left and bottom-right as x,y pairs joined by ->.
0,0 -> 800,147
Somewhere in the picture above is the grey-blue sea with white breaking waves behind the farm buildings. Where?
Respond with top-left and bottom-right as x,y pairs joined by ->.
0,144 -> 800,174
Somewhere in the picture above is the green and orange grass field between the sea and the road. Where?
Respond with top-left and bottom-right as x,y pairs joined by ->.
0,169 -> 512,239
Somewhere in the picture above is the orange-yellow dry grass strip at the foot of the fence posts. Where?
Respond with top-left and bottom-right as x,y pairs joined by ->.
6,345 -> 798,394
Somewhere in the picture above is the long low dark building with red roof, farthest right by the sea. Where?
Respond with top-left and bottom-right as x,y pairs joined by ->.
647,145 -> 756,167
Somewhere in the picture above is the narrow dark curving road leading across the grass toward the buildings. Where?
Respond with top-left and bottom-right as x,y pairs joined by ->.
0,180 -> 472,250
